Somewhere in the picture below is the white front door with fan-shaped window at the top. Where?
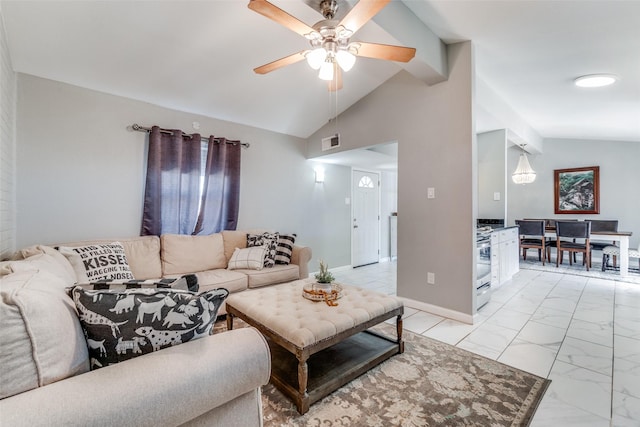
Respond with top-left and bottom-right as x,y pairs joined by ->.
351,169 -> 380,267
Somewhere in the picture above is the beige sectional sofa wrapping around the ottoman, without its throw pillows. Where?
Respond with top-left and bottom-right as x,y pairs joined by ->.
0,231 -> 311,426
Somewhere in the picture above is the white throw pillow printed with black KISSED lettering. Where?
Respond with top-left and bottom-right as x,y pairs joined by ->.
58,242 -> 135,283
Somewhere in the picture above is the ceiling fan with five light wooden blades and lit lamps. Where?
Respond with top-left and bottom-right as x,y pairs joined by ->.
248,0 -> 416,91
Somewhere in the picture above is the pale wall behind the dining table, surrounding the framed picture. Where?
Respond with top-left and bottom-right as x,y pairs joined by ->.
507,139 -> 640,247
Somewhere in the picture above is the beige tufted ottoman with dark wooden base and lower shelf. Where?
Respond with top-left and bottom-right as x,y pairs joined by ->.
226,279 -> 404,414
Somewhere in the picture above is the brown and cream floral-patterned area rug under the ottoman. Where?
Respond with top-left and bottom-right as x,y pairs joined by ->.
218,324 -> 551,427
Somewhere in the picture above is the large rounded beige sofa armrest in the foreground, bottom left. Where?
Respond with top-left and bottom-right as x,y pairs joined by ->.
0,328 -> 271,426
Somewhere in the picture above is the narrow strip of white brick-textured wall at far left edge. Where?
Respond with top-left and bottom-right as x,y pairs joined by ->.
0,12 -> 17,259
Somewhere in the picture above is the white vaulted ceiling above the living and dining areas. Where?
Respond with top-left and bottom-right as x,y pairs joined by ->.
0,0 -> 640,141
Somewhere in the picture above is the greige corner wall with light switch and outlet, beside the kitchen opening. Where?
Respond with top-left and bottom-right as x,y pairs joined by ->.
307,42 -> 477,315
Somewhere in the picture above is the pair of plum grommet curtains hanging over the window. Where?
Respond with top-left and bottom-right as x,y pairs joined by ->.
141,126 -> 241,236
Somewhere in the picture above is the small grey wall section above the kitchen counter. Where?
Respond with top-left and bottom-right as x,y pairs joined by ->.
477,129 -> 507,219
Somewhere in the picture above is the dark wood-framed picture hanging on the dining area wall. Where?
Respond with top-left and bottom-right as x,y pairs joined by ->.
553,166 -> 600,215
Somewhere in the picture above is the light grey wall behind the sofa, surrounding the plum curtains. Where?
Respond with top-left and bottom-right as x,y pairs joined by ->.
16,74 -> 350,270
